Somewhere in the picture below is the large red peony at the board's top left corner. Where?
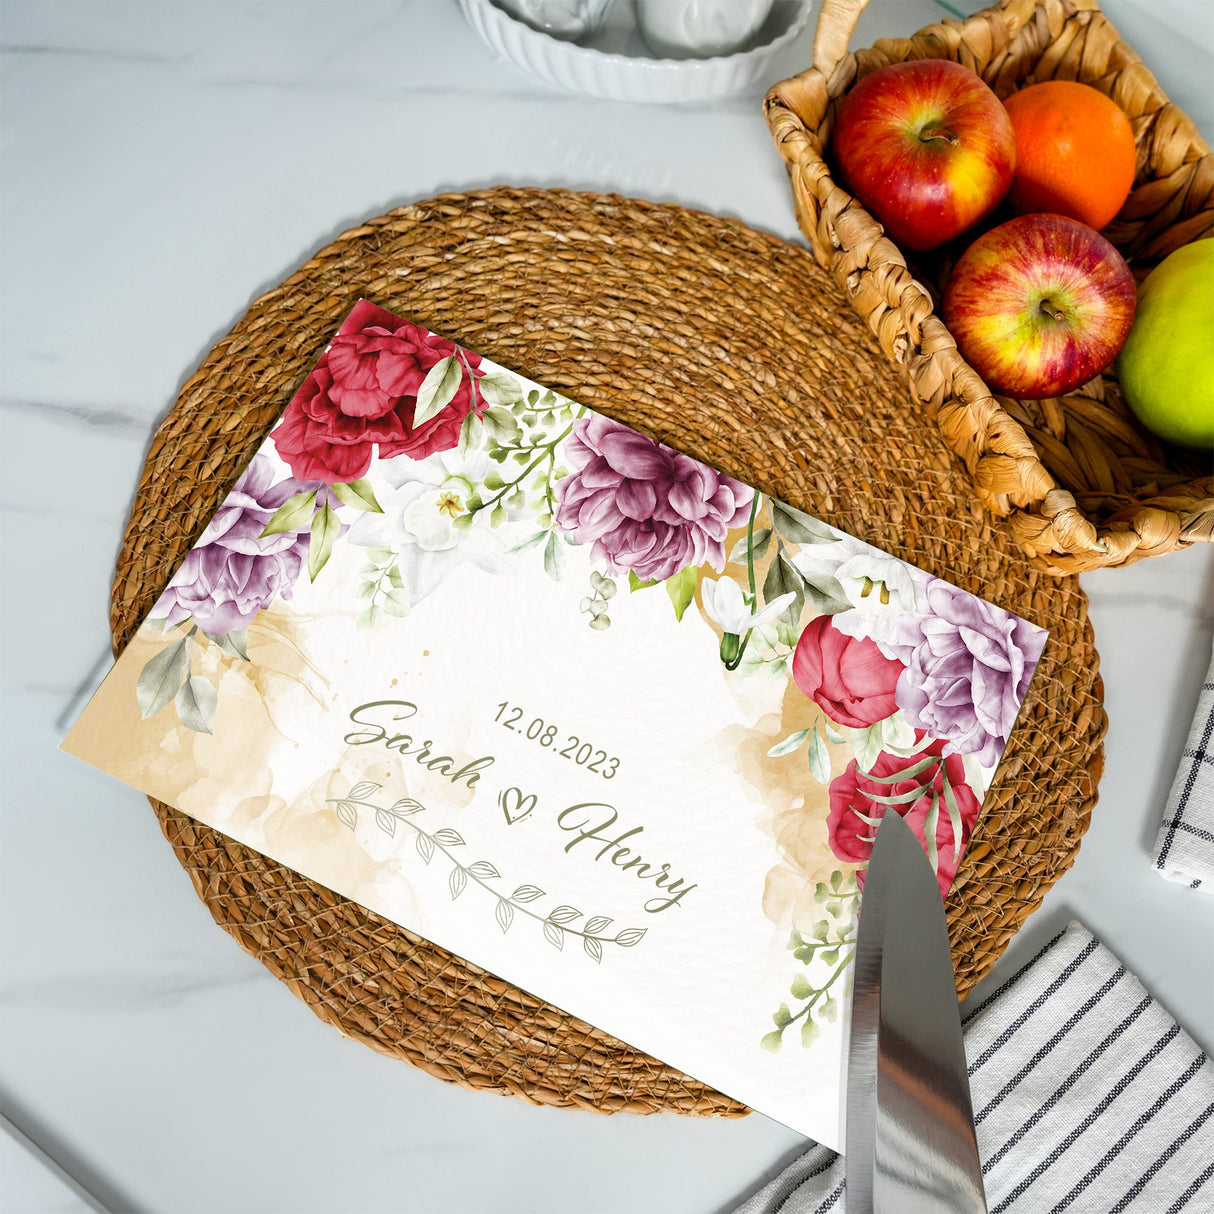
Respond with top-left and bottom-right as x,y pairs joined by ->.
272,300 -> 481,484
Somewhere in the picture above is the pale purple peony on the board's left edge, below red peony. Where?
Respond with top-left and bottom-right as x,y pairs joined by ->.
152,455 -> 316,636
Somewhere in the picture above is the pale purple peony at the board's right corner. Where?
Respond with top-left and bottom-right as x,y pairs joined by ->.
894,578 -> 1045,767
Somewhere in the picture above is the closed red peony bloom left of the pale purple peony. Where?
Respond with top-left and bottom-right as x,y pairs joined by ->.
793,615 -> 906,730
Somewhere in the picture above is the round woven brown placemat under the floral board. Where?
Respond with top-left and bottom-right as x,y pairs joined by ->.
112,189 -> 1106,1116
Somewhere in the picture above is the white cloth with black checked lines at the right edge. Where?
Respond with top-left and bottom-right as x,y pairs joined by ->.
1155,657 -> 1214,892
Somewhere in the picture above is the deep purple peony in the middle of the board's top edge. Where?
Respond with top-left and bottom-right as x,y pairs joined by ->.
556,418 -> 754,582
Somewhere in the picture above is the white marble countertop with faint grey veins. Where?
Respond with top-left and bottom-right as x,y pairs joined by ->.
0,0 -> 1214,1214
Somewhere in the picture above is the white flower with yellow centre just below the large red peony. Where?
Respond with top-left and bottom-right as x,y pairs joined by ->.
348,450 -> 523,606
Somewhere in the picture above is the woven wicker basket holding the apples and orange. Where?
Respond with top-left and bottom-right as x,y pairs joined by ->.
765,0 -> 1214,573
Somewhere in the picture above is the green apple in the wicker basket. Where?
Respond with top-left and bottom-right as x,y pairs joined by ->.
1117,239 -> 1214,448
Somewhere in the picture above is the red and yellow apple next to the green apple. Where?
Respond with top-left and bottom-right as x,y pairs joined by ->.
944,215 -> 1138,401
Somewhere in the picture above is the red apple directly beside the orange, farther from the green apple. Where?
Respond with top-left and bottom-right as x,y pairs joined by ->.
834,59 -> 1016,249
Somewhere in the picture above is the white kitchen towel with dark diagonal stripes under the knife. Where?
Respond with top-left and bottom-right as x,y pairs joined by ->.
734,923 -> 1214,1214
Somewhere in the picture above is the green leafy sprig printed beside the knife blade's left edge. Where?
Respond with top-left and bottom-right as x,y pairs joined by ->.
759,869 -> 860,1054
